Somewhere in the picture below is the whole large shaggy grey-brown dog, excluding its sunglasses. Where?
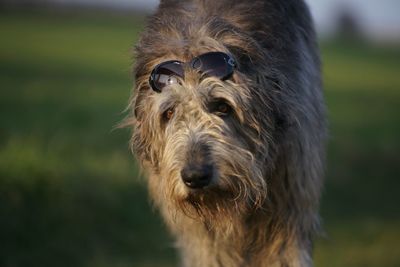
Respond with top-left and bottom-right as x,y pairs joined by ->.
128,0 -> 325,267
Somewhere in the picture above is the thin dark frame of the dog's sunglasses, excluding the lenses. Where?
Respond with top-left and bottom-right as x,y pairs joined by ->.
149,51 -> 237,93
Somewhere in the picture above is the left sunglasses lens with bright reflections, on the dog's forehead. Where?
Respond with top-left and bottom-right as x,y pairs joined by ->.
150,61 -> 184,92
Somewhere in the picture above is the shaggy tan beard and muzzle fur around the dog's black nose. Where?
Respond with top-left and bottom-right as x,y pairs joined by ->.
159,149 -> 267,222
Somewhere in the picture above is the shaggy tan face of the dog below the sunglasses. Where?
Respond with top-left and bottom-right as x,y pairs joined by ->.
133,47 -> 276,222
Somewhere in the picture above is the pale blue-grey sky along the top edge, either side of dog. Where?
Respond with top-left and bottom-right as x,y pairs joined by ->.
53,0 -> 400,40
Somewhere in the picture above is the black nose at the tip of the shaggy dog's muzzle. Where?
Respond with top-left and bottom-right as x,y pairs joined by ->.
181,165 -> 213,189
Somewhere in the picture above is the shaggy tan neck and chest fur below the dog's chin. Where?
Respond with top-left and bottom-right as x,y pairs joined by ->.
166,212 -> 310,267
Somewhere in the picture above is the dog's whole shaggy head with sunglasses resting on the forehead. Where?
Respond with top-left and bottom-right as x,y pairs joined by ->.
126,1 -> 278,222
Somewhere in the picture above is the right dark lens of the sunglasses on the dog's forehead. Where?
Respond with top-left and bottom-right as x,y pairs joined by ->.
193,52 -> 234,79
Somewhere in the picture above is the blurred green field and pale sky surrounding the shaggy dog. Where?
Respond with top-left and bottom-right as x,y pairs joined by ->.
0,0 -> 400,267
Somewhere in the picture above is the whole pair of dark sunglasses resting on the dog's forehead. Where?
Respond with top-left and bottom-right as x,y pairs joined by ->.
149,52 -> 236,93
